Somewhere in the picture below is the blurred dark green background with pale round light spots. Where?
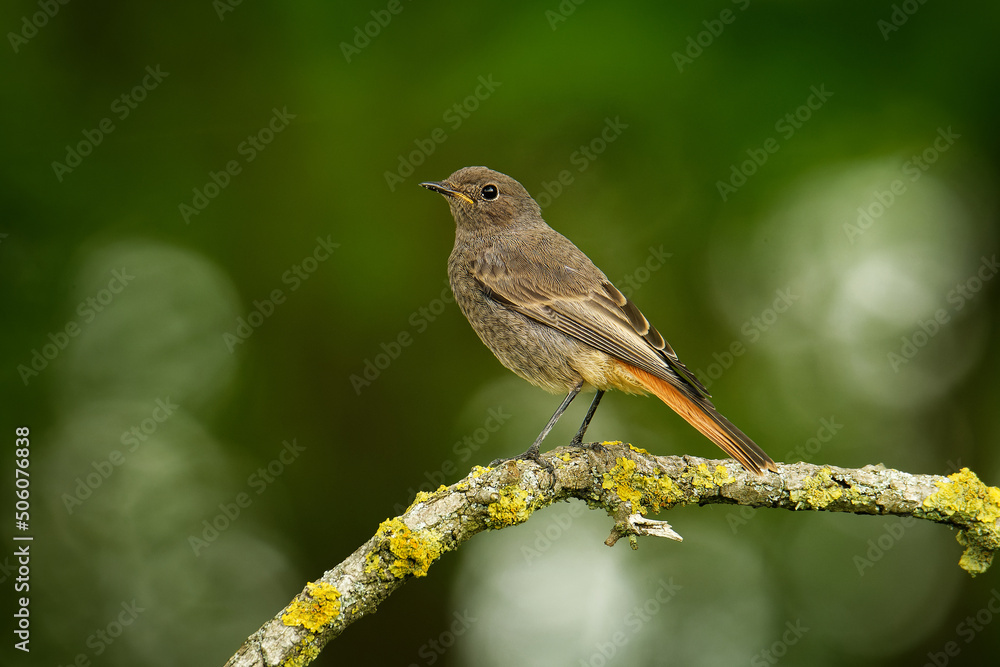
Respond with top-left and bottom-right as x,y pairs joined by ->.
0,0 -> 1000,667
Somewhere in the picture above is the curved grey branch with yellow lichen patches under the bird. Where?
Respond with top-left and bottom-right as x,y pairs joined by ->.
227,442 -> 1000,667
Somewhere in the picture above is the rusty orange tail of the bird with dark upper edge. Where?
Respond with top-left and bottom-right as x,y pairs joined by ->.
619,362 -> 778,474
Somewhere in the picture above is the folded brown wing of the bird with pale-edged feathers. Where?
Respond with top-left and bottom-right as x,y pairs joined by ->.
471,247 -> 711,405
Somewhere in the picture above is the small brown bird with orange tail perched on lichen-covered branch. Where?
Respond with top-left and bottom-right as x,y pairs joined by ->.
420,167 -> 777,474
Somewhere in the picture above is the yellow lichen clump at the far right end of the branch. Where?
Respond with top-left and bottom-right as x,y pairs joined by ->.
923,468 -> 1000,576
